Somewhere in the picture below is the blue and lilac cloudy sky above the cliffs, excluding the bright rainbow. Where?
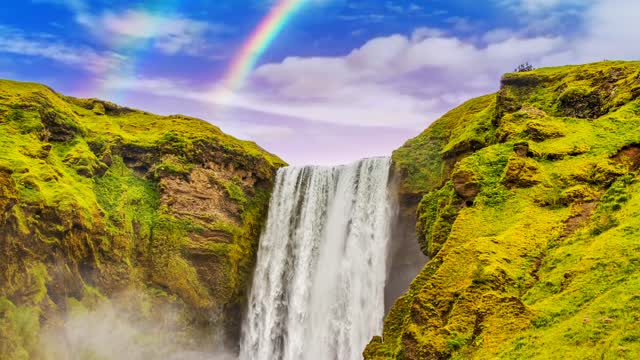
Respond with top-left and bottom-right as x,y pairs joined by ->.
0,0 -> 640,165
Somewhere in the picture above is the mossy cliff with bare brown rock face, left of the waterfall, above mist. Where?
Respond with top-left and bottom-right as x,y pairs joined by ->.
0,80 -> 285,359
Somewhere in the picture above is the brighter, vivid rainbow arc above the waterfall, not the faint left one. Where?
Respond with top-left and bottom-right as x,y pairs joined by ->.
218,0 -> 306,100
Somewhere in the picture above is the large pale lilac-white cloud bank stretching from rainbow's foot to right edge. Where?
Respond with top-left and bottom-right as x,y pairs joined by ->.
89,0 -> 640,134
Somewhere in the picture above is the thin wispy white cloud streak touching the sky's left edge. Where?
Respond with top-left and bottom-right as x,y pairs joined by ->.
0,26 -> 125,73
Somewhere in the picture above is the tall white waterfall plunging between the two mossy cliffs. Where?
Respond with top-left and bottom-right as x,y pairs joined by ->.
240,158 -> 394,360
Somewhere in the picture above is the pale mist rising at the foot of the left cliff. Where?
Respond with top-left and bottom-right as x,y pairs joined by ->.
38,293 -> 237,360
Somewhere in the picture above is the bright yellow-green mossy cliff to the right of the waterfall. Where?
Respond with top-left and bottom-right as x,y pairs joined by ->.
364,62 -> 640,359
